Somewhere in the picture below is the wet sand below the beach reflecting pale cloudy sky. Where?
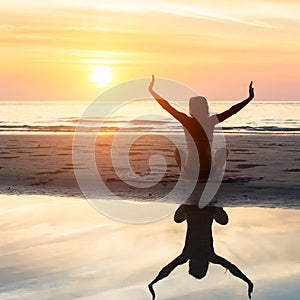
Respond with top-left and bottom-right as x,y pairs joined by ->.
0,195 -> 300,300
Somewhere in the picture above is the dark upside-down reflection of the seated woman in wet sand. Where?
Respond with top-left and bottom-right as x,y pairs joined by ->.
148,205 -> 253,299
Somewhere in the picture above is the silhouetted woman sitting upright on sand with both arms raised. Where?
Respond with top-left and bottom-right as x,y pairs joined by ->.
148,75 -> 254,179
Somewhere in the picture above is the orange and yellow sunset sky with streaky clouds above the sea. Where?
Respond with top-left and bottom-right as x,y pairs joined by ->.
0,0 -> 300,100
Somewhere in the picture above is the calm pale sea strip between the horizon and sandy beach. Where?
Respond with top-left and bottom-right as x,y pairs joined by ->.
0,100 -> 300,134
